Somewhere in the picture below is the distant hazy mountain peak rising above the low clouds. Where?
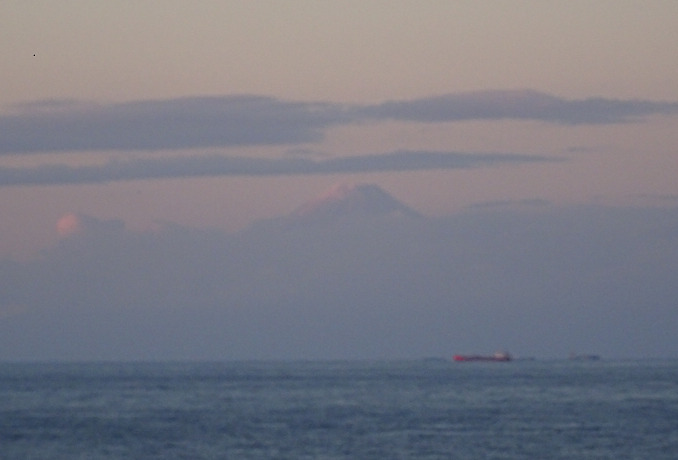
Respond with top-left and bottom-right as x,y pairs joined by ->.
291,184 -> 421,220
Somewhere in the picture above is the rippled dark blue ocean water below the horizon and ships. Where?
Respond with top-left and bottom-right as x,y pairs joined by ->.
0,360 -> 678,460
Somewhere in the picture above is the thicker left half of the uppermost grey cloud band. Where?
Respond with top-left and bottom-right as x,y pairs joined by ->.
0,95 -> 348,153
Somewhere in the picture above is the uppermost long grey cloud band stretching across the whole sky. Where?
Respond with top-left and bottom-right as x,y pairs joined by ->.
0,90 -> 678,154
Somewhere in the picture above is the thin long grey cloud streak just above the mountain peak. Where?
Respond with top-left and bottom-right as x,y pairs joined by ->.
0,151 -> 558,187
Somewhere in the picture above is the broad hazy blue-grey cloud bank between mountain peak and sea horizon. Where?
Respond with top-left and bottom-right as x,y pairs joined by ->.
0,196 -> 678,360
